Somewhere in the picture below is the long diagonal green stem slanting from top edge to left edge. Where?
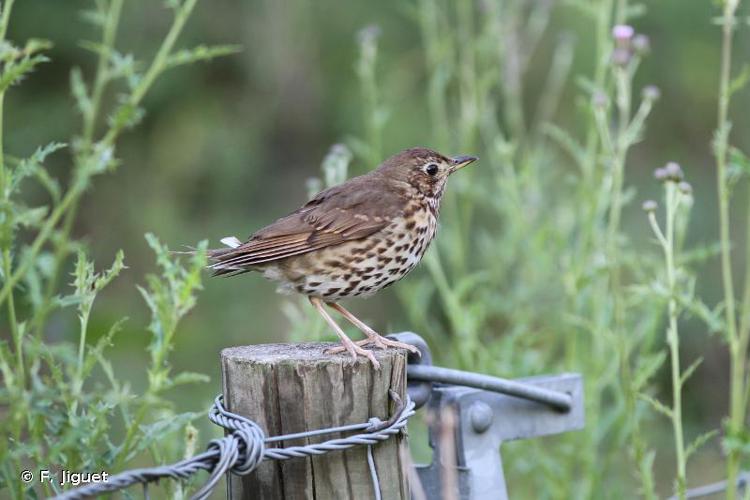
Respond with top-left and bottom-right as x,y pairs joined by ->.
0,0 -> 197,304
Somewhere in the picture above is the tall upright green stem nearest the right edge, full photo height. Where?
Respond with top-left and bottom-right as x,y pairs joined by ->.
715,0 -> 750,500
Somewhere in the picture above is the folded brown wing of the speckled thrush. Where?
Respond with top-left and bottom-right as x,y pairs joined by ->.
209,175 -> 403,275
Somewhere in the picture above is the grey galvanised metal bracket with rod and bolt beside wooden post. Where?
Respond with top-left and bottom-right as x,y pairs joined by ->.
392,332 -> 584,500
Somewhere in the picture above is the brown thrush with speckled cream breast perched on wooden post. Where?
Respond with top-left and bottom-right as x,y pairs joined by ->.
207,147 -> 477,369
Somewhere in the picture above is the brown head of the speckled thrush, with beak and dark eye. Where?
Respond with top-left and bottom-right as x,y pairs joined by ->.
377,148 -> 477,199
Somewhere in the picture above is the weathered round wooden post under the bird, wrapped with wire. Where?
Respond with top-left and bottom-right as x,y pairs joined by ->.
221,343 -> 409,500
